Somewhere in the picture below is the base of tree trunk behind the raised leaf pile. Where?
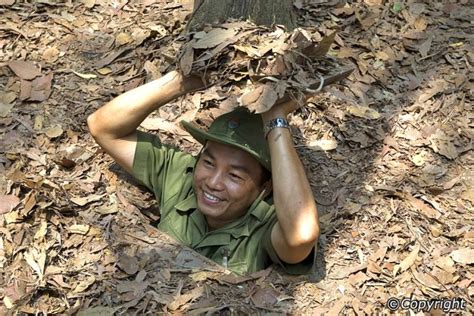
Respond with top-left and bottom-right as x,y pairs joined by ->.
188,0 -> 296,30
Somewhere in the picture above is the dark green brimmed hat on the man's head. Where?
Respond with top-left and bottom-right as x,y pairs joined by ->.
181,107 -> 272,172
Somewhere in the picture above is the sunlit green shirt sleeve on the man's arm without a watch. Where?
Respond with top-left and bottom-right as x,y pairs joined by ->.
133,131 -> 196,204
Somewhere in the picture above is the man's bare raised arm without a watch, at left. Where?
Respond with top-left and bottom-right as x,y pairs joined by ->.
87,71 -> 203,173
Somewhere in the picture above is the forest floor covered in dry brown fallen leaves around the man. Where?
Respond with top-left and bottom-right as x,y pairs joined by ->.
0,0 -> 474,315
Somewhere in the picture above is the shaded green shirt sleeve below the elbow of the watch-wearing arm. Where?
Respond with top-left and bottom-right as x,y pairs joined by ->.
262,217 -> 316,275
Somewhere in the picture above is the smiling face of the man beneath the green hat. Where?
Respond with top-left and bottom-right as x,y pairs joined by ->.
193,141 -> 264,229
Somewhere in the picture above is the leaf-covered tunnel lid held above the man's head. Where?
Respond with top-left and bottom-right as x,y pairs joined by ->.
178,21 -> 352,113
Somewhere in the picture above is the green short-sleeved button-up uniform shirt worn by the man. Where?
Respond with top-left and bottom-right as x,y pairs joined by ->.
133,132 -> 314,274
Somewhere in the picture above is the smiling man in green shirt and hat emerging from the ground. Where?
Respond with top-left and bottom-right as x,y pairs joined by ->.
87,72 -> 319,274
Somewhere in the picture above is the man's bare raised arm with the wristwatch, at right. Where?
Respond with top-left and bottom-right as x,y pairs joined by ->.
262,101 -> 319,263
